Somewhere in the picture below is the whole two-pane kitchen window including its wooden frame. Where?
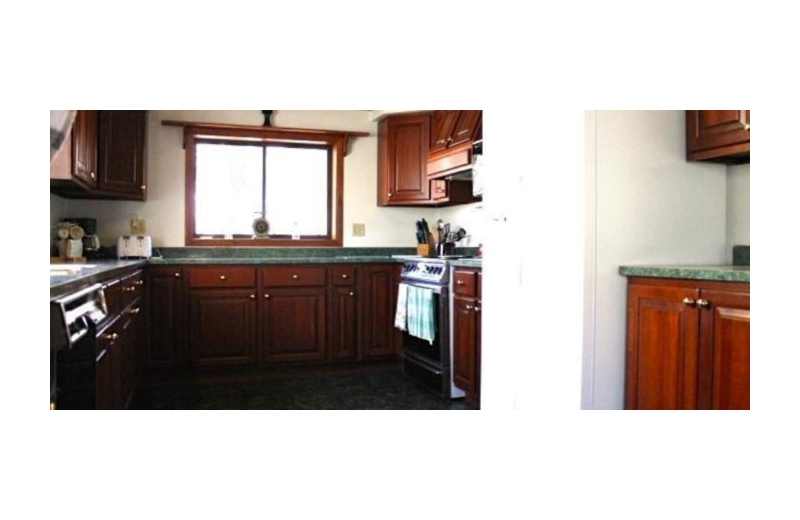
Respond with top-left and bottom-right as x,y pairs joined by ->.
186,129 -> 345,247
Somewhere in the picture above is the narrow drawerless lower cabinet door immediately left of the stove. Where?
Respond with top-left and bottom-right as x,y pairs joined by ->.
362,265 -> 399,359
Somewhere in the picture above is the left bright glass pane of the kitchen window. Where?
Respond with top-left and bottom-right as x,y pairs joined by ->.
195,143 -> 263,236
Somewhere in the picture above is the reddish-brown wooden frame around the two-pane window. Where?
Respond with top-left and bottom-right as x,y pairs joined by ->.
184,126 -> 347,247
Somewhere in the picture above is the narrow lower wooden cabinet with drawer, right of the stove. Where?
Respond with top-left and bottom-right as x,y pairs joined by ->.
453,269 -> 483,405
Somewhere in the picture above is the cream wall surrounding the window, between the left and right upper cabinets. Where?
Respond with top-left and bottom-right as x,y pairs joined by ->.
64,110 -> 462,247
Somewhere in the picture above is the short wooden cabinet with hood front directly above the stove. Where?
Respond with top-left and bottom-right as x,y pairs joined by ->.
427,110 -> 483,179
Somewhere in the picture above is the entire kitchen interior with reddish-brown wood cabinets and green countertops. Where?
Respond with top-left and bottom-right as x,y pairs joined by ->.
50,110 -> 749,410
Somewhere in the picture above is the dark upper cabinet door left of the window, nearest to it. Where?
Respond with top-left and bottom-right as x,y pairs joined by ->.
98,110 -> 147,200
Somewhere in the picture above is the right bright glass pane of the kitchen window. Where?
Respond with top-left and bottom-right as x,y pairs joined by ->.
266,146 -> 329,236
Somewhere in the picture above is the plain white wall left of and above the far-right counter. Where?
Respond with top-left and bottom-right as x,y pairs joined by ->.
584,110 -> 727,409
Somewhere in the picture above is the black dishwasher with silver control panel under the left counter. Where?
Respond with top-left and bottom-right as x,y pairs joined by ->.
50,284 -> 108,410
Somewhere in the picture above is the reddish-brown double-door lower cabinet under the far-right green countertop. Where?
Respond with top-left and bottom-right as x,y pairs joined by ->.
626,278 -> 750,410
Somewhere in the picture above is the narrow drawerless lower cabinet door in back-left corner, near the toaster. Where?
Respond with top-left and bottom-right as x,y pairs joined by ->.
147,268 -> 185,366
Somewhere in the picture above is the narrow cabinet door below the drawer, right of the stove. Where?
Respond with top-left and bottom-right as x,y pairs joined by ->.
453,296 -> 479,398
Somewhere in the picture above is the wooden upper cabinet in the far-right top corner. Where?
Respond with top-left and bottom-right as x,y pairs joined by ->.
686,110 -> 750,163
